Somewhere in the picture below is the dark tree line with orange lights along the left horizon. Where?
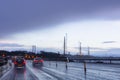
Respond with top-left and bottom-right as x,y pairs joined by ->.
0,50 -> 66,61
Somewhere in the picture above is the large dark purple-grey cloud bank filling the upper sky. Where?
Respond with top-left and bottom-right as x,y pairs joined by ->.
0,0 -> 120,37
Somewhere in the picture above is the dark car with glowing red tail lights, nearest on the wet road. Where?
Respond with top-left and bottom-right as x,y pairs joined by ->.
14,57 -> 26,68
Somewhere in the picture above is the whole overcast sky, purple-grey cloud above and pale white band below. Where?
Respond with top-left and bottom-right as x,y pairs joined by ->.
0,0 -> 120,56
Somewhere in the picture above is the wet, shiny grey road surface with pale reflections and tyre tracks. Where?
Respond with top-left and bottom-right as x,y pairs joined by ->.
0,61 -> 120,80
